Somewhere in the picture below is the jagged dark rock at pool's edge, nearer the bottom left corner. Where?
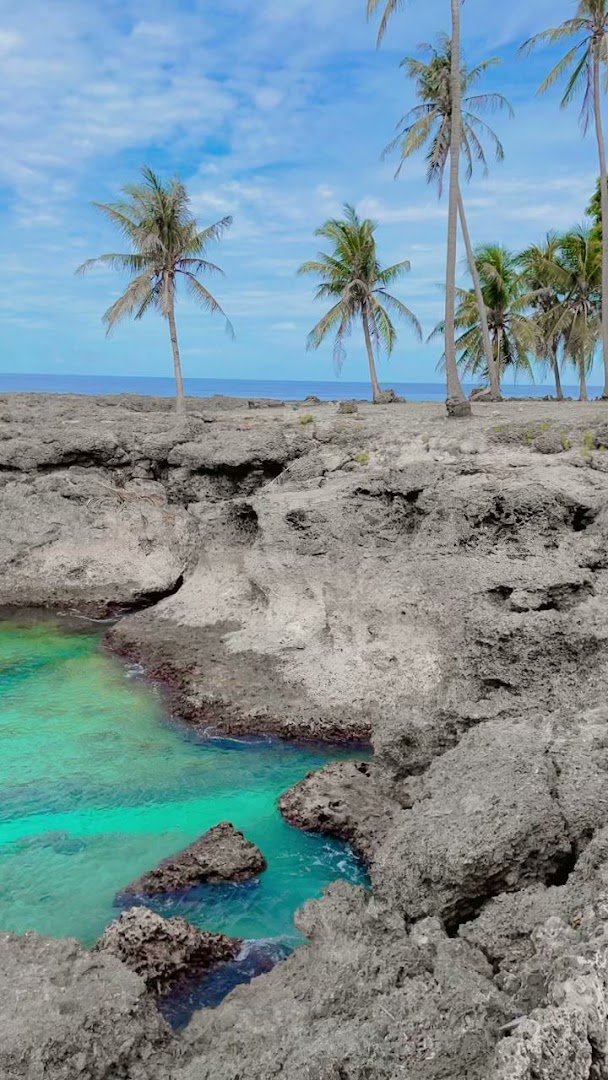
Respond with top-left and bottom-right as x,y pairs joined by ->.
95,907 -> 243,993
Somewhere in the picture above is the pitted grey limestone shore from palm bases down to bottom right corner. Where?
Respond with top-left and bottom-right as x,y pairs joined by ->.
5,397 -> 608,1080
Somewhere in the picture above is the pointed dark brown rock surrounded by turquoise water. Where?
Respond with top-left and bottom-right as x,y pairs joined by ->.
117,821 -> 266,901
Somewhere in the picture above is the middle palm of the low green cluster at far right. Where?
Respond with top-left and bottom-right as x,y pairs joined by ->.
519,232 -> 564,401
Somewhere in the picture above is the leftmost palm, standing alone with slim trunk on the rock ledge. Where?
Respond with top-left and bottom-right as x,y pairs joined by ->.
77,166 -> 233,409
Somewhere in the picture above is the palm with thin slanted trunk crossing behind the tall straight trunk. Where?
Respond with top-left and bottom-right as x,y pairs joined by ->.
384,33 -> 512,401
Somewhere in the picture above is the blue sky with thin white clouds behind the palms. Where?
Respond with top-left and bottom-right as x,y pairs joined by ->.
0,0 -> 597,382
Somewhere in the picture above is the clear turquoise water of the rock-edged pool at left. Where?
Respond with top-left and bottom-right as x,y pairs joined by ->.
0,616 -> 365,955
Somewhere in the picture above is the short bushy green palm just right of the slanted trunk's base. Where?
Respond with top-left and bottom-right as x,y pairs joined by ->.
431,244 -> 537,379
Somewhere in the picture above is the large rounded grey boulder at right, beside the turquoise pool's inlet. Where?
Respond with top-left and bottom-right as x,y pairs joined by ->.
371,721 -> 571,926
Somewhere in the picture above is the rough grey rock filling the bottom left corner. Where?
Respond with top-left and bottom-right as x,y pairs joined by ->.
0,934 -> 176,1080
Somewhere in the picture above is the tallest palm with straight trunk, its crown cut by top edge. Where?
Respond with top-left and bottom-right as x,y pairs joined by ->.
367,0 -> 471,417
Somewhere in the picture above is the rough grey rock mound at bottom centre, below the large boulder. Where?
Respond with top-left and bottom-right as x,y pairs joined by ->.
175,883 -> 513,1080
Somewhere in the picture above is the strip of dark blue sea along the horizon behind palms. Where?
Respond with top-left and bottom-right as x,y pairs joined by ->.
0,374 -> 602,402
